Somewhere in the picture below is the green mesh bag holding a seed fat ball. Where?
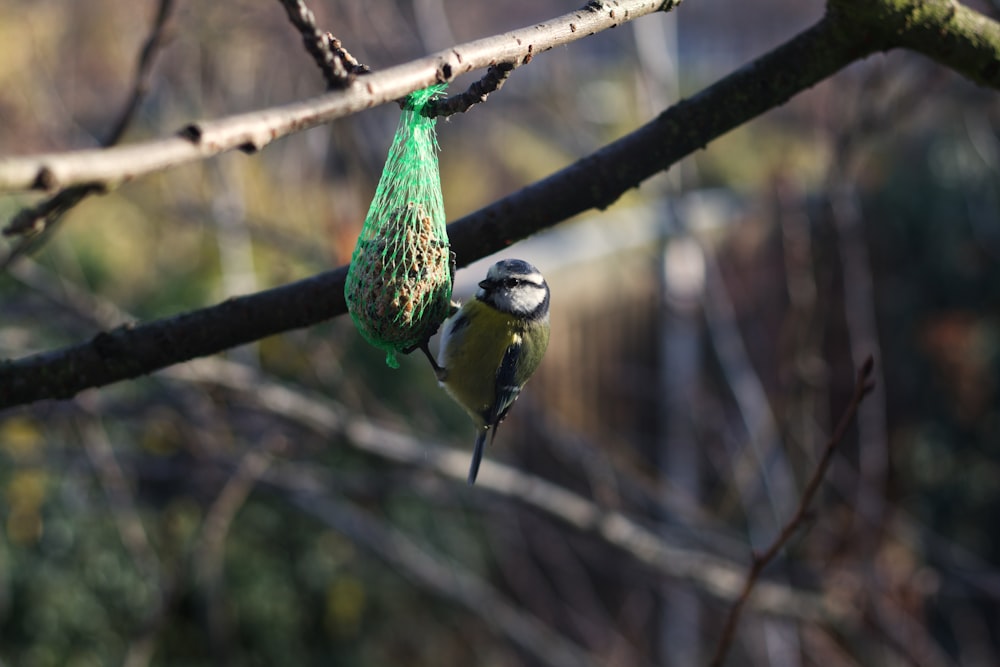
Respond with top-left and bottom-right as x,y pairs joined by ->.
344,84 -> 452,368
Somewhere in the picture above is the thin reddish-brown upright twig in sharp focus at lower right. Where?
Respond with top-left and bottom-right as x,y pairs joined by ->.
710,357 -> 875,667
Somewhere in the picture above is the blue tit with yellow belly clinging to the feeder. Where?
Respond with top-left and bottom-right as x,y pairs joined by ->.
424,259 -> 549,484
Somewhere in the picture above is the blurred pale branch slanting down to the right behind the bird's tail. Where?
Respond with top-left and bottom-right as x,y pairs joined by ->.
167,359 -> 849,624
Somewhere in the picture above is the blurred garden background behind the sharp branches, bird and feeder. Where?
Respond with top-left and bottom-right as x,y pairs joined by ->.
0,0 -> 1000,667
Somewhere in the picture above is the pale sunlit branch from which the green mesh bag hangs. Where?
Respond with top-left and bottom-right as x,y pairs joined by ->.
0,0 -> 680,197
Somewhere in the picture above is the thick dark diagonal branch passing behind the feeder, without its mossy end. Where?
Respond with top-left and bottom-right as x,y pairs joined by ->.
0,11 -> 868,409
